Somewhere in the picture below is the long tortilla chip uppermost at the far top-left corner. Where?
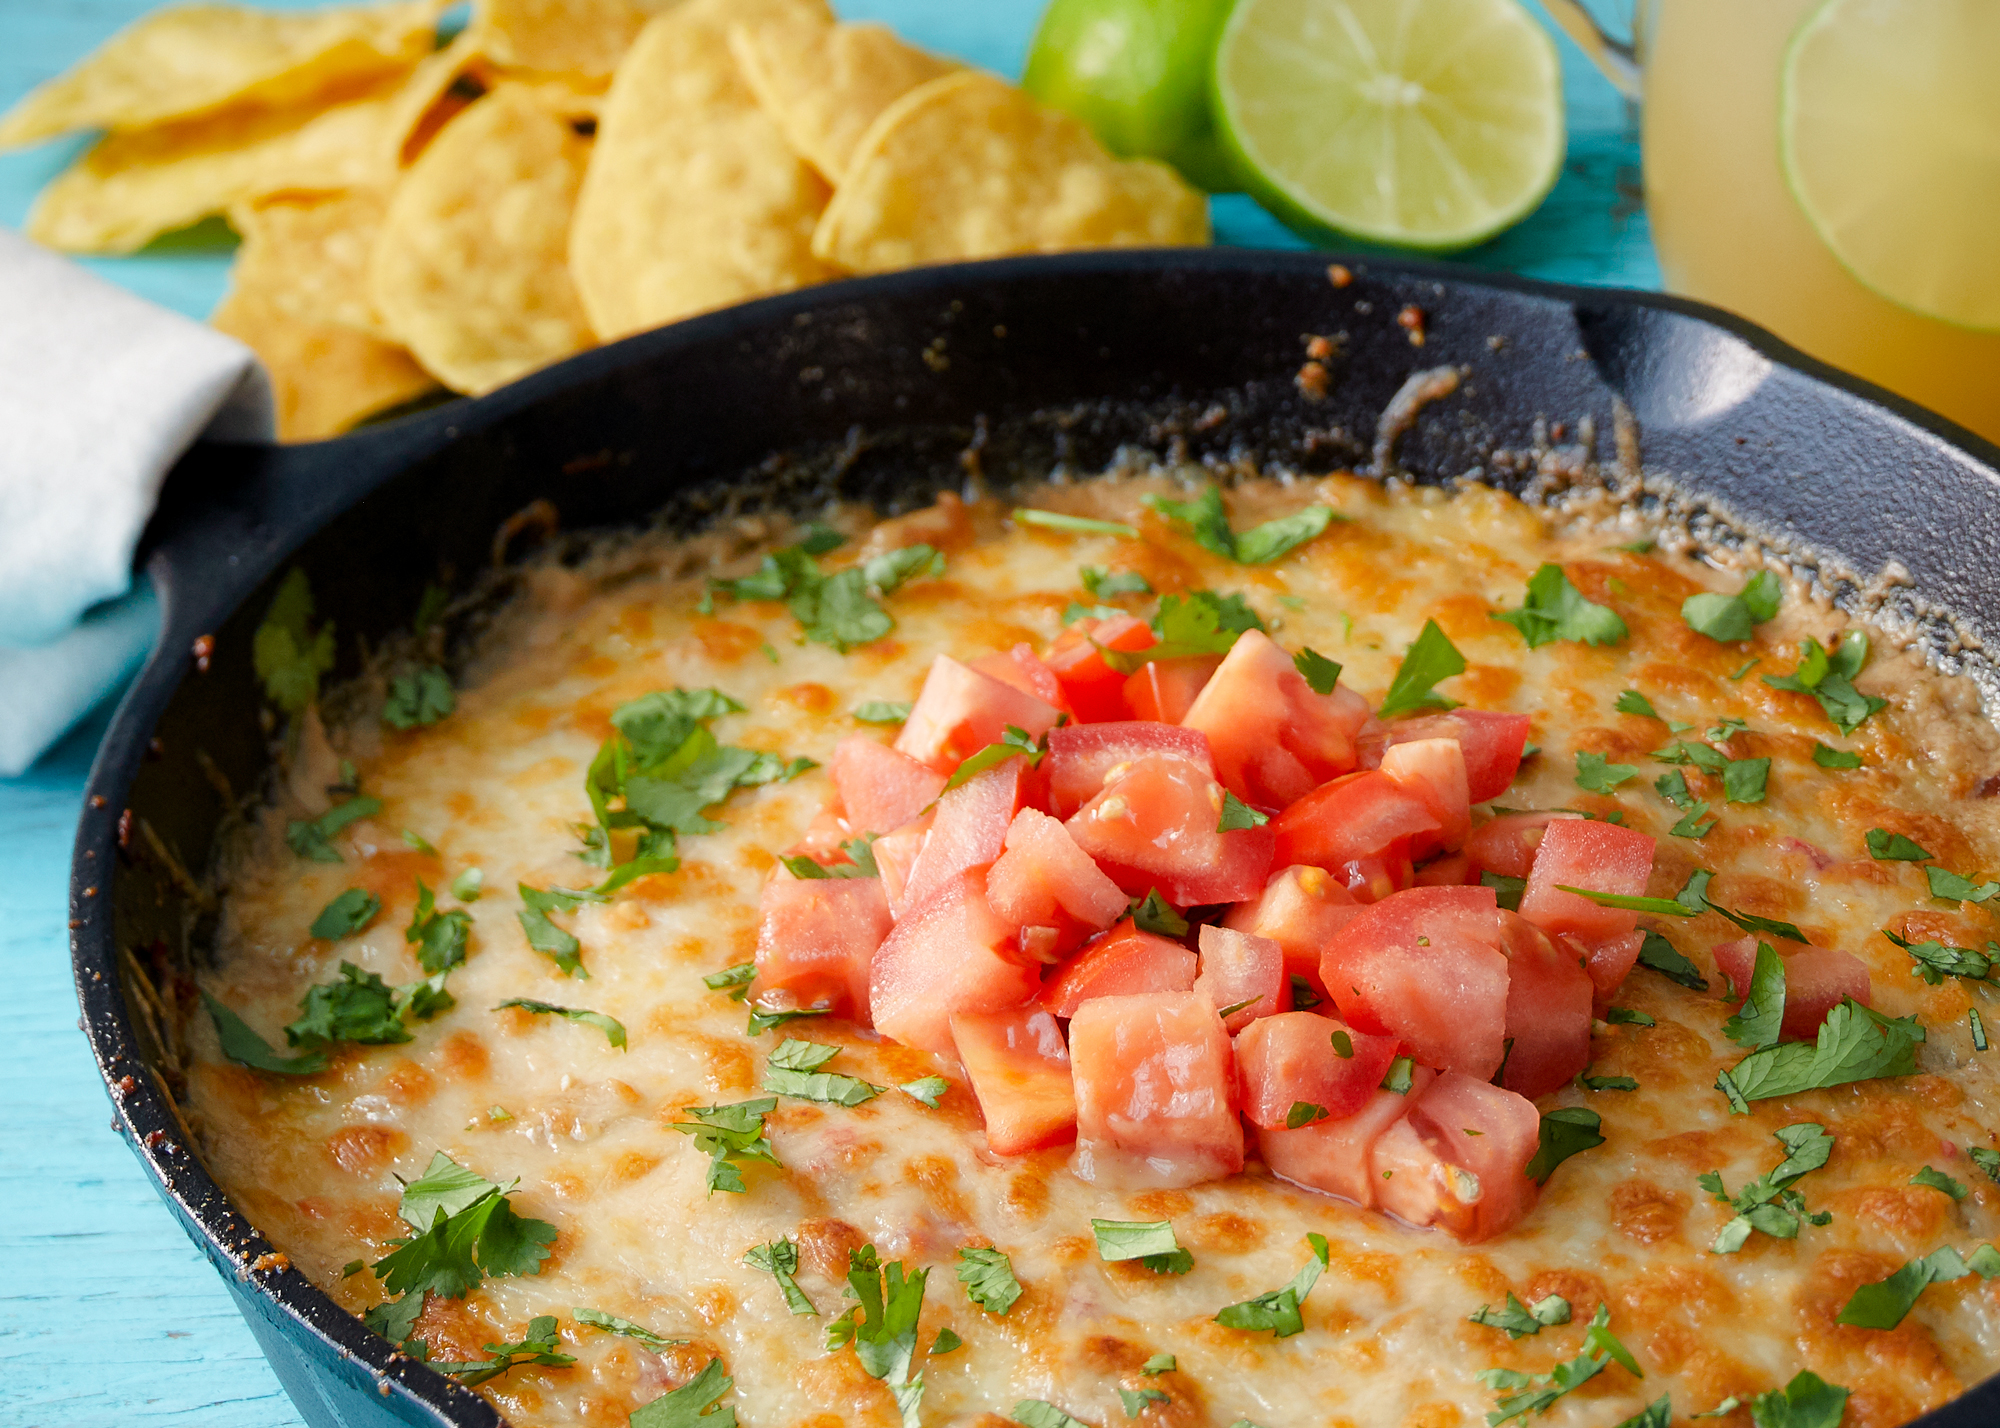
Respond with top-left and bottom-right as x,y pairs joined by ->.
0,0 -> 448,148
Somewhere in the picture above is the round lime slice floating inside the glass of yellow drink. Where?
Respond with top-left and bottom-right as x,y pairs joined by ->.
1778,0 -> 2000,330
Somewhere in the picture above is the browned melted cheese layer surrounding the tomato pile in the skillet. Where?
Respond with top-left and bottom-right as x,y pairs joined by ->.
188,476 -> 2000,1428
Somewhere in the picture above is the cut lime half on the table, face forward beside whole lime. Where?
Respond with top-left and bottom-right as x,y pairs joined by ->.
1210,0 -> 1564,252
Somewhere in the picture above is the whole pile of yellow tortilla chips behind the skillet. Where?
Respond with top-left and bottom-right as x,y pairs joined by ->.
0,0 -> 1208,440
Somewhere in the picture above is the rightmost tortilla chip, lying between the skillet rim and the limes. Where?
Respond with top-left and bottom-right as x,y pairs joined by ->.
812,72 -> 1208,272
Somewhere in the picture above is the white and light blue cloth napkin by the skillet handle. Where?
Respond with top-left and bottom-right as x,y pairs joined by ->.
0,228 -> 272,776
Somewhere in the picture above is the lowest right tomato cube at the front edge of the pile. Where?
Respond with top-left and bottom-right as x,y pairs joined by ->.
1368,1072 -> 1542,1244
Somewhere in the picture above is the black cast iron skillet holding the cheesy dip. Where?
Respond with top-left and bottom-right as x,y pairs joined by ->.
70,250 -> 2000,1428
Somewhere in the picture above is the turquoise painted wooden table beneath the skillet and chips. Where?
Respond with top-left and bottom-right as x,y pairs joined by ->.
0,0 -> 1658,1428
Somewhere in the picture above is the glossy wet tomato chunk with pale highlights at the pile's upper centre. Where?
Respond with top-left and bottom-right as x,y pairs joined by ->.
1066,754 -> 1272,908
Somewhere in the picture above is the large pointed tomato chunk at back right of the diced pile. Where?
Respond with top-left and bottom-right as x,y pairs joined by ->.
1180,630 -> 1368,808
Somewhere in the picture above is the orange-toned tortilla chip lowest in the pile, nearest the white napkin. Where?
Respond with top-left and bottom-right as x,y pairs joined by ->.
208,276 -> 438,442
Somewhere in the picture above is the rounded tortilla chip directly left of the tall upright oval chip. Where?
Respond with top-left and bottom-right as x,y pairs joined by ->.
368,84 -> 594,392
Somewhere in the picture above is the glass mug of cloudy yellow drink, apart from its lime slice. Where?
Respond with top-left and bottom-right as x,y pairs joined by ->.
1542,0 -> 2000,442
